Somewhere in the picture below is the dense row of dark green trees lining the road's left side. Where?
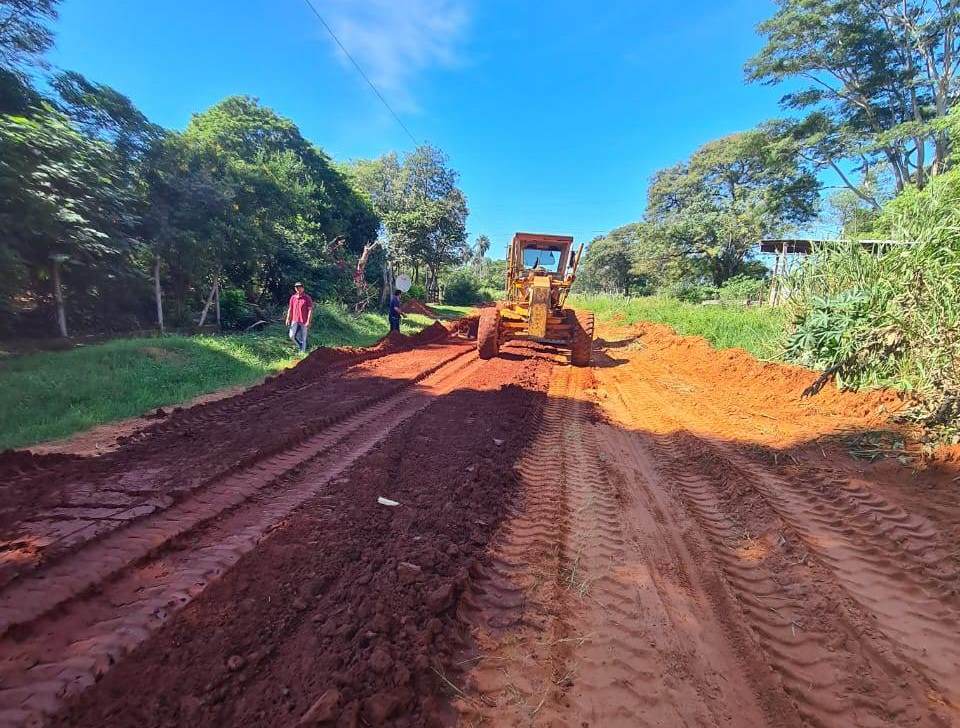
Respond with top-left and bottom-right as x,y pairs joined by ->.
0,0 -> 467,336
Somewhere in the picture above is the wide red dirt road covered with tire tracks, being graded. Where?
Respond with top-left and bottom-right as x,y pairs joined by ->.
0,326 -> 960,728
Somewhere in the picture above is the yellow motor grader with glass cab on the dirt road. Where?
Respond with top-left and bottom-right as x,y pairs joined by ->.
477,233 -> 593,367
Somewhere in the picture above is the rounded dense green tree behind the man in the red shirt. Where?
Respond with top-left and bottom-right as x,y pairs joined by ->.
172,97 -> 379,312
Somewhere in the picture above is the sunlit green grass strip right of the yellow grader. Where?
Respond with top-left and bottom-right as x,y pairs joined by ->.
570,295 -> 786,359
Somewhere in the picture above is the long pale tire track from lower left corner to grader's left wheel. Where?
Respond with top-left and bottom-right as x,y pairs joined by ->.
0,345 -> 488,726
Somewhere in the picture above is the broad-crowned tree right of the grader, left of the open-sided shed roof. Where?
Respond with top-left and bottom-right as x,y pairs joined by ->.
635,127 -> 819,286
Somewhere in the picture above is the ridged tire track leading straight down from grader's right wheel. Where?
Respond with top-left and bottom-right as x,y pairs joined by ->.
458,367 -> 772,726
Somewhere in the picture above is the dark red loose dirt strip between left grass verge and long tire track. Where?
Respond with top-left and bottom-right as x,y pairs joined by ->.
0,324 -> 456,587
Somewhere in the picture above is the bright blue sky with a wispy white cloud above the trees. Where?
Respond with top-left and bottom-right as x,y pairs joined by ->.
51,0 -> 796,253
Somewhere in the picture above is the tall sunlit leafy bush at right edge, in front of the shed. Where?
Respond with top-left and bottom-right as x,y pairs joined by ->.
786,233 -> 960,436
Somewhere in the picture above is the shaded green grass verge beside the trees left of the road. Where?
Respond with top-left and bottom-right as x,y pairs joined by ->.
0,304 -> 442,450
